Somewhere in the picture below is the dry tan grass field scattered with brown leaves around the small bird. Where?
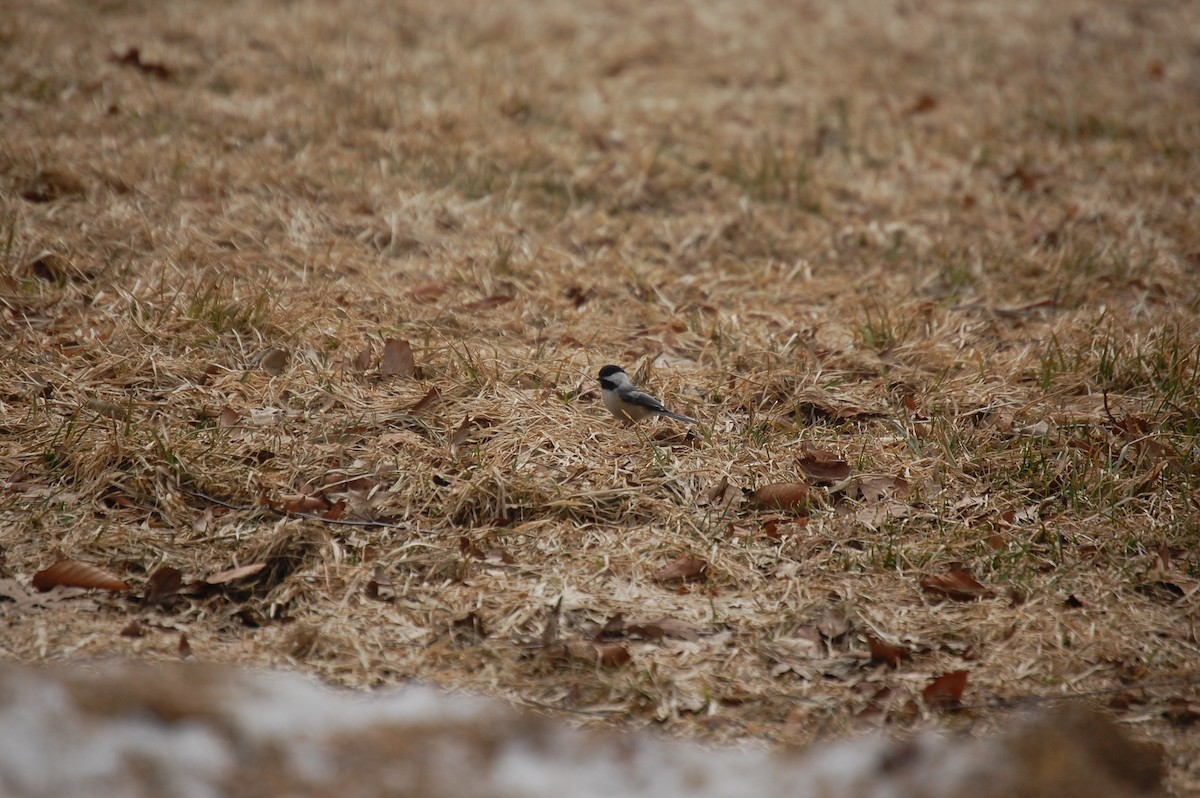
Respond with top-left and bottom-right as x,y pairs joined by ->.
0,0 -> 1200,794
